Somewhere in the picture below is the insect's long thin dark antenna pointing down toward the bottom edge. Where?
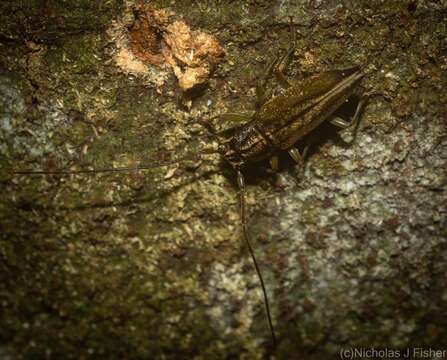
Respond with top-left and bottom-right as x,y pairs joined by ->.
237,170 -> 276,348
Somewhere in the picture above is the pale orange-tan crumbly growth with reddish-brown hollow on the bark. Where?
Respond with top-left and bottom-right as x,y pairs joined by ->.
109,3 -> 225,91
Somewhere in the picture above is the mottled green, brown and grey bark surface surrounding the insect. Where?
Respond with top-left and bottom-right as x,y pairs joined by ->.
0,0 -> 447,359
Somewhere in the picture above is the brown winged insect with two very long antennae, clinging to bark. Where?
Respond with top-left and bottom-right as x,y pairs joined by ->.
14,22 -> 372,347
